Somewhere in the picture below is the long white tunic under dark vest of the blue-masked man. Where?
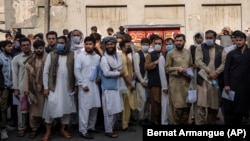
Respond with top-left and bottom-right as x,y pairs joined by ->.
43,54 -> 76,119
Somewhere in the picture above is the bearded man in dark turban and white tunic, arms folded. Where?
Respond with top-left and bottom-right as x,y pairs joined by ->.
100,36 -> 124,138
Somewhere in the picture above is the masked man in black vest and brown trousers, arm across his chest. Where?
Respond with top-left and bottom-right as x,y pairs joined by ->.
144,37 -> 163,124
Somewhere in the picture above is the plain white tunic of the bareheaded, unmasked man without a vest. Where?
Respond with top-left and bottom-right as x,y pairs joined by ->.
74,51 -> 101,109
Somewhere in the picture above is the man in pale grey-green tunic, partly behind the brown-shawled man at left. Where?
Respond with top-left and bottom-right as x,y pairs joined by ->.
12,38 -> 32,137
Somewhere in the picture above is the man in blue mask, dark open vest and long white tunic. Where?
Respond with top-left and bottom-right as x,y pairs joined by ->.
42,36 -> 77,141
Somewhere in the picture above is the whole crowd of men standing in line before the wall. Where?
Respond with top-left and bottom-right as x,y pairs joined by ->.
0,26 -> 250,141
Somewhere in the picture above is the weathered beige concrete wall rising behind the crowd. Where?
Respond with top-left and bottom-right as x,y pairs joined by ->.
5,0 -> 250,46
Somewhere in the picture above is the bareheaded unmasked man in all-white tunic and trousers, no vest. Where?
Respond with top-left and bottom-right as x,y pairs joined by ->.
74,36 -> 101,139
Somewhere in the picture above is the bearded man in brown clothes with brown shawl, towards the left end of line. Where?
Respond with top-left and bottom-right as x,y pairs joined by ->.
23,40 -> 46,139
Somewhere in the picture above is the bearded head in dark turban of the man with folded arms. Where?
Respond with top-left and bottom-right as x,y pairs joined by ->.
103,36 -> 117,55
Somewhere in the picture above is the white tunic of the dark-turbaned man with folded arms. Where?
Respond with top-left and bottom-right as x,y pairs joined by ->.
100,57 -> 123,116
